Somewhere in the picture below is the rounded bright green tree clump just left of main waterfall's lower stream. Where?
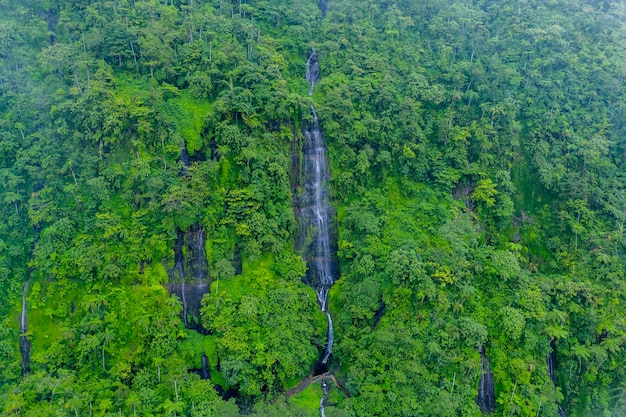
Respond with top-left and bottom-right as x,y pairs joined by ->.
202,263 -> 323,397
